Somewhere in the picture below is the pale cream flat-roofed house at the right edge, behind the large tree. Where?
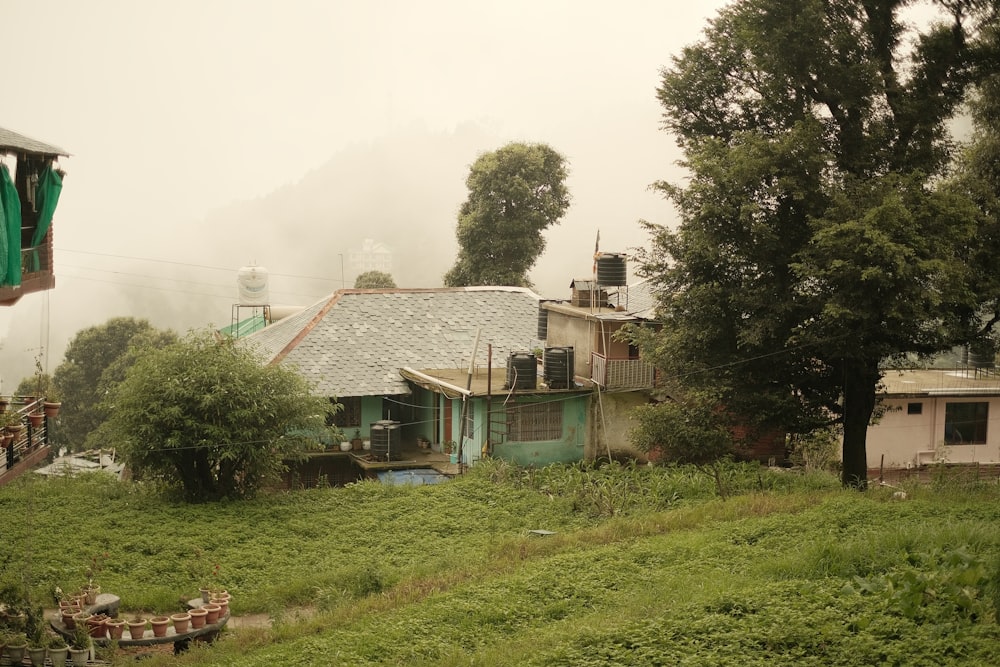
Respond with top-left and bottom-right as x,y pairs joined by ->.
867,367 -> 1000,469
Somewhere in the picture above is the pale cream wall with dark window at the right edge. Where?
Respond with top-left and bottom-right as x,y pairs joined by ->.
867,396 -> 1000,469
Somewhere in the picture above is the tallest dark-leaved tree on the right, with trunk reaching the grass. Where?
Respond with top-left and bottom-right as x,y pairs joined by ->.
642,0 -> 997,486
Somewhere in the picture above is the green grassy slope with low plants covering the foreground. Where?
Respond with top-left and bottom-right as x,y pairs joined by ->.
0,462 -> 1000,666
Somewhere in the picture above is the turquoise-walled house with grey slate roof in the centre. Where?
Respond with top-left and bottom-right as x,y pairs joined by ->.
239,287 -> 589,464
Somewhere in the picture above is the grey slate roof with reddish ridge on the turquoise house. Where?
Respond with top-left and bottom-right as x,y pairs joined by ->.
238,287 -> 540,397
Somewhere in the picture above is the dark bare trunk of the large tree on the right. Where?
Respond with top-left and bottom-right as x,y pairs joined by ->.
841,359 -> 881,489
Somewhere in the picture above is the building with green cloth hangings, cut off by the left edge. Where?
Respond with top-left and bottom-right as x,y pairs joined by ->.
0,128 -> 69,306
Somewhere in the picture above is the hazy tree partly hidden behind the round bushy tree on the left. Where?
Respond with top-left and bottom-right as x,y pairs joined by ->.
52,317 -> 175,448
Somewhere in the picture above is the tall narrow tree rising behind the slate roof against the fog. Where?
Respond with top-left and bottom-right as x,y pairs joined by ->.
444,143 -> 570,287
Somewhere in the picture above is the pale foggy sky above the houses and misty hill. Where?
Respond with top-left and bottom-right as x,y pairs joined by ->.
0,0 -> 725,391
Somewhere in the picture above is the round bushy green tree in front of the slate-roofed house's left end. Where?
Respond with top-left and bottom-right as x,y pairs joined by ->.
98,332 -> 331,501
